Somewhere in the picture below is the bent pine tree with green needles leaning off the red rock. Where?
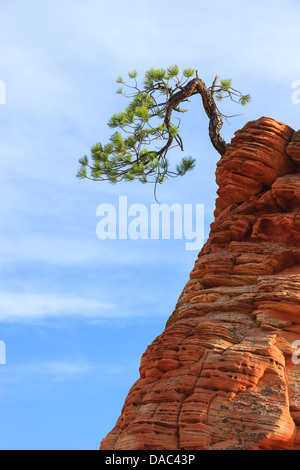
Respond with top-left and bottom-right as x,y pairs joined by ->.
77,65 -> 250,193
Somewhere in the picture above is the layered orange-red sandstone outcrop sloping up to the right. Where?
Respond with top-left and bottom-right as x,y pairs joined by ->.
100,117 -> 300,450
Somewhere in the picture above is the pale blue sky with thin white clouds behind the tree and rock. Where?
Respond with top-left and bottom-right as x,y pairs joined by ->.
0,0 -> 300,450
